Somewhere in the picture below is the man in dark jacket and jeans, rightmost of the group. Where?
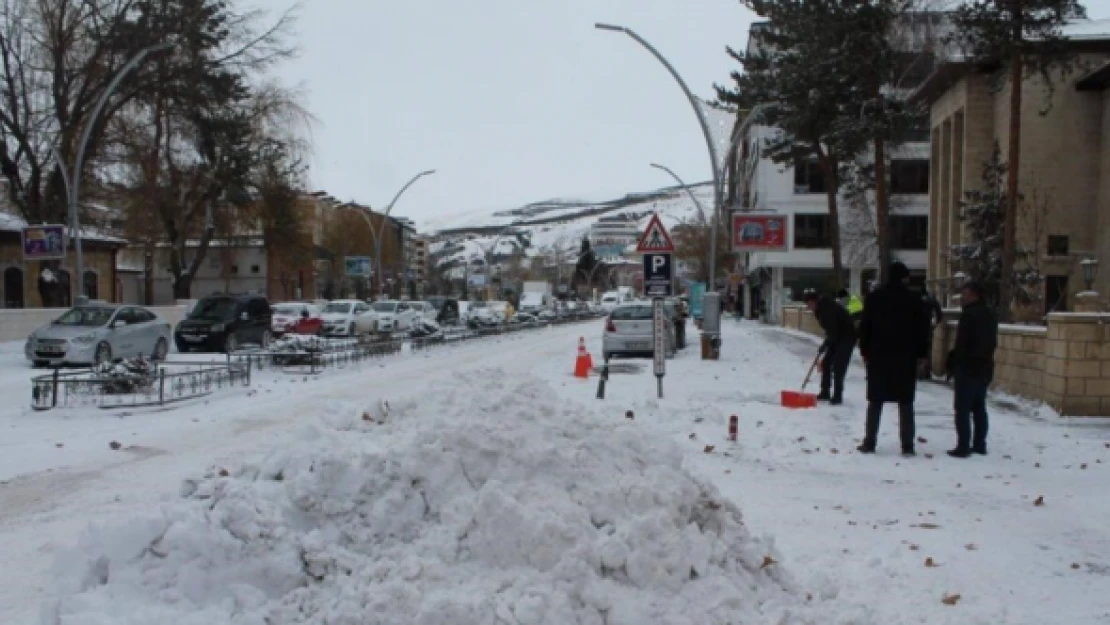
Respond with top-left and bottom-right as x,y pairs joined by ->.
948,282 -> 998,457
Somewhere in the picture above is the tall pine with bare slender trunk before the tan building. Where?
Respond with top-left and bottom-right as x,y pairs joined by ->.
950,0 -> 1086,321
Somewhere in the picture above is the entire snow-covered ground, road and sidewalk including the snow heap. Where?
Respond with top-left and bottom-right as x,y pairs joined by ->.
0,323 -> 1110,625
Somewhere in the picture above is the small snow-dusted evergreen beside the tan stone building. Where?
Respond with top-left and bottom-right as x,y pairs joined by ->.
951,143 -> 1043,305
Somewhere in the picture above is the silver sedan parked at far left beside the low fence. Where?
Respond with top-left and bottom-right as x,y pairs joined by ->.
23,304 -> 172,366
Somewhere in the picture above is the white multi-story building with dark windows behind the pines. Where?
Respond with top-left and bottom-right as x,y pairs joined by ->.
733,23 -> 930,321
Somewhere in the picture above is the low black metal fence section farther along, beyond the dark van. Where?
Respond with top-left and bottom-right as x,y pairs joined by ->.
228,339 -> 403,374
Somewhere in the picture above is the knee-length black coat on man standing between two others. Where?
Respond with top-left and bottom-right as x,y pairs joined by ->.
859,282 -> 929,403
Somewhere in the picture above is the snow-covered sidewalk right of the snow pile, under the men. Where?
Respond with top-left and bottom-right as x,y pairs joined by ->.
582,321 -> 1110,625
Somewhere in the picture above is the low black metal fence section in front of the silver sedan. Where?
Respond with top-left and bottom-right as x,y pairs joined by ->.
31,362 -> 251,411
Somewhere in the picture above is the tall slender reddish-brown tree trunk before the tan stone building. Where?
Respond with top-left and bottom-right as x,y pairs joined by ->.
998,17 -> 1022,322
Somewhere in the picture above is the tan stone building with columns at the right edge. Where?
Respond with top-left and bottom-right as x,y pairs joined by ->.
915,20 -> 1110,319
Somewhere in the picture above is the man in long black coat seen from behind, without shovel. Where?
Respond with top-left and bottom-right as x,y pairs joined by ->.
857,262 -> 929,455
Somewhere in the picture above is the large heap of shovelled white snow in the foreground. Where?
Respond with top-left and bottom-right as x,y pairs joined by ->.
43,371 -> 861,625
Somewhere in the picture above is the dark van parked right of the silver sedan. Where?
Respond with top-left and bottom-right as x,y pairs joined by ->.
173,294 -> 273,353
